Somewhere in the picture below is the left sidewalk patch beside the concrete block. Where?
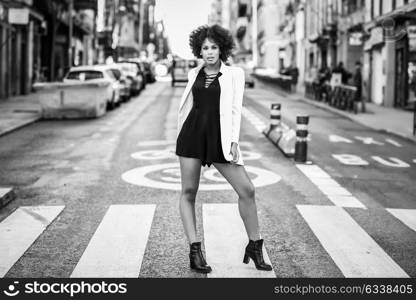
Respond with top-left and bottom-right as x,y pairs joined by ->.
0,93 -> 41,136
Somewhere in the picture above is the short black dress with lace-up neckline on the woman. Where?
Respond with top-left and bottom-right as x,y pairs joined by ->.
176,68 -> 229,167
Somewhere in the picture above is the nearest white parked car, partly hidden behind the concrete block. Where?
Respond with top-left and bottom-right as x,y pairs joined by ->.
64,65 -> 122,108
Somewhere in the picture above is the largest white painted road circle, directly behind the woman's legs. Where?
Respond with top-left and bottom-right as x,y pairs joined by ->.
121,163 -> 282,191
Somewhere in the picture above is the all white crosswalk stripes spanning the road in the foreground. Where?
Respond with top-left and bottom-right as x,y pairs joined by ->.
0,203 -> 416,278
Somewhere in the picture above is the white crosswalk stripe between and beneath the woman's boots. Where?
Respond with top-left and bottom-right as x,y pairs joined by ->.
202,204 -> 276,278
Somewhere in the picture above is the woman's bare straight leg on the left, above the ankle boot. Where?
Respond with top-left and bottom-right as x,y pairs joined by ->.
179,156 -> 201,244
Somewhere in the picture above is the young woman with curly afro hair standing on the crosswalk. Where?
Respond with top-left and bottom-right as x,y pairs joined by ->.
176,25 -> 272,273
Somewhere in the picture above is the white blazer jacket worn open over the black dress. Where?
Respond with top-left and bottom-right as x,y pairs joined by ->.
176,62 -> 245,166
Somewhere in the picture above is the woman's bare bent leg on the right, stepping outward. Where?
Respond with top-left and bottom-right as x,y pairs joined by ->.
214,163 -> 260,241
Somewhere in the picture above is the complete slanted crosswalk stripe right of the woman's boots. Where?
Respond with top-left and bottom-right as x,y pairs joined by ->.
297,205 -> 409,278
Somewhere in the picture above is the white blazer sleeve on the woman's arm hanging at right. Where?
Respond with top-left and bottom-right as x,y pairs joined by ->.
231,67 -> 245,144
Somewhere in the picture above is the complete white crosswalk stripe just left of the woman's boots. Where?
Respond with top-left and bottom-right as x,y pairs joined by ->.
71,205 -> 156,278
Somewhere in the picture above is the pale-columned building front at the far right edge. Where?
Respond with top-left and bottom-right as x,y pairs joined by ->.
364,0 -> 416,108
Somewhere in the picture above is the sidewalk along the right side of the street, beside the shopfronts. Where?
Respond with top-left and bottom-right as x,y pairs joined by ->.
257,77 -> 416,142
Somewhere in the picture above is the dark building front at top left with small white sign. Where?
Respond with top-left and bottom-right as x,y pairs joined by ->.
0,0 -> 96,99
